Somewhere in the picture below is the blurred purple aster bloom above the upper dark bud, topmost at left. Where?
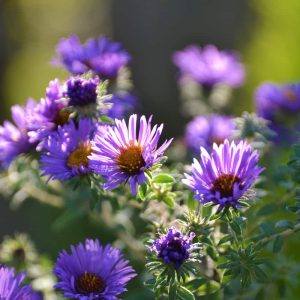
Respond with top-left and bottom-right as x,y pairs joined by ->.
56,35 -> 130,79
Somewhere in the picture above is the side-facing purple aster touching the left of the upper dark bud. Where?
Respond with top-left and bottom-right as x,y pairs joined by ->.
28,79 -> 70,150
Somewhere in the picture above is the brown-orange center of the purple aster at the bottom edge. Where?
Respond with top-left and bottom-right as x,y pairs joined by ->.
76,272 -> 106,295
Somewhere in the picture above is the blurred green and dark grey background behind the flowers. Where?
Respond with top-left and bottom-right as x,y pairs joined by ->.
0,0 -> 300,298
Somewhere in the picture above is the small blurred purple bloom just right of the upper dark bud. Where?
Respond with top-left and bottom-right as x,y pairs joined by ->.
102,92 -> 137,119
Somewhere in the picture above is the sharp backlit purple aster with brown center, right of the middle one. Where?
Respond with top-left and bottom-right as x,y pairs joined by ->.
183,140 -> 263,212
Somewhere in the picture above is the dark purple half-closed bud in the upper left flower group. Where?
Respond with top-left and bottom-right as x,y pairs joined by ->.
63,77 -> 99,106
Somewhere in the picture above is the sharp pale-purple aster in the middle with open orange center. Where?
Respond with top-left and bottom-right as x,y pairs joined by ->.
89,115 -> 172,195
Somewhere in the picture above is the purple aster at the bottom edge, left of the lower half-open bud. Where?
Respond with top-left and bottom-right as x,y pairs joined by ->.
54,240 -> 136,300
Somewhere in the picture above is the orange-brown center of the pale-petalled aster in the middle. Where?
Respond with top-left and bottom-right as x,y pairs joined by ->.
117,145 -> 146,175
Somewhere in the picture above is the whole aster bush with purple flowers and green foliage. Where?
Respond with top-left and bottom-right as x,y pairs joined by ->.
0,35 -> 300,300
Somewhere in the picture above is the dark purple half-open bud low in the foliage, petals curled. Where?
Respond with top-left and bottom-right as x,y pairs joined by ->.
150,226 -> 195,269
